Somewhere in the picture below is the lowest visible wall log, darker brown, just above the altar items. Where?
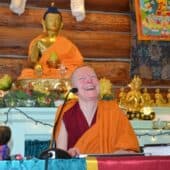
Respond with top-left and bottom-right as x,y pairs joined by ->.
0,58 -> 130,86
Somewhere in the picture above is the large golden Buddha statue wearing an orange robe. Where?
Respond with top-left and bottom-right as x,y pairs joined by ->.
18,3 -> 83,90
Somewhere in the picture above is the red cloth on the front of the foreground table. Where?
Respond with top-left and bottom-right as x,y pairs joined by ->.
97,156 -> 170,170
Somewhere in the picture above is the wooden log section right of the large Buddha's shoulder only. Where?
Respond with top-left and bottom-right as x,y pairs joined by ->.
57,31 -> 130,58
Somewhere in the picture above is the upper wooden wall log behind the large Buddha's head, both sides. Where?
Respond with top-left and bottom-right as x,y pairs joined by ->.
0,7 -> 130,32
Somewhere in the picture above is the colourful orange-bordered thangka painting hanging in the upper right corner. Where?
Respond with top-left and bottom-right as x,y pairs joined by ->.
135,0 -> 170,41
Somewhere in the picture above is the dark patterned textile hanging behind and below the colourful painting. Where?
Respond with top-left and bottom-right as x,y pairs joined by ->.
129,0 -> 170,80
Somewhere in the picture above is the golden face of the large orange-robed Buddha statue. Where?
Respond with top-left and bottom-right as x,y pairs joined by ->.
44,13 -> 62,33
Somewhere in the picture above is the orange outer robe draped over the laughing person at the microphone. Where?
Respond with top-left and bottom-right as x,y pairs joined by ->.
55,100 -> 139,154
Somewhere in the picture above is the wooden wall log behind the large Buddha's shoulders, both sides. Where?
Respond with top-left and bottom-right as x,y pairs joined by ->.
0,27 -> 130,58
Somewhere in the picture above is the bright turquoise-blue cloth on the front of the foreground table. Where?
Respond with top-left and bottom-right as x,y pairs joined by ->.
0,159 -> 86,170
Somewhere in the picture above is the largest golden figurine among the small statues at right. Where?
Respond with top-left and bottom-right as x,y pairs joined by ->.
126,76 -> 144,112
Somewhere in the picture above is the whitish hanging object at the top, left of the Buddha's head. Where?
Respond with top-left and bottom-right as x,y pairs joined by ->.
9,0 -> 27,15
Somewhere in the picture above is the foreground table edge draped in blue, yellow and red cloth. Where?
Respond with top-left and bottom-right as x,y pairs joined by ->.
0,156 -> 170,170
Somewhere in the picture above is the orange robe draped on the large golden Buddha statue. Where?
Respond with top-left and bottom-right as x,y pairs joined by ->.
18,34 -> 83,80
